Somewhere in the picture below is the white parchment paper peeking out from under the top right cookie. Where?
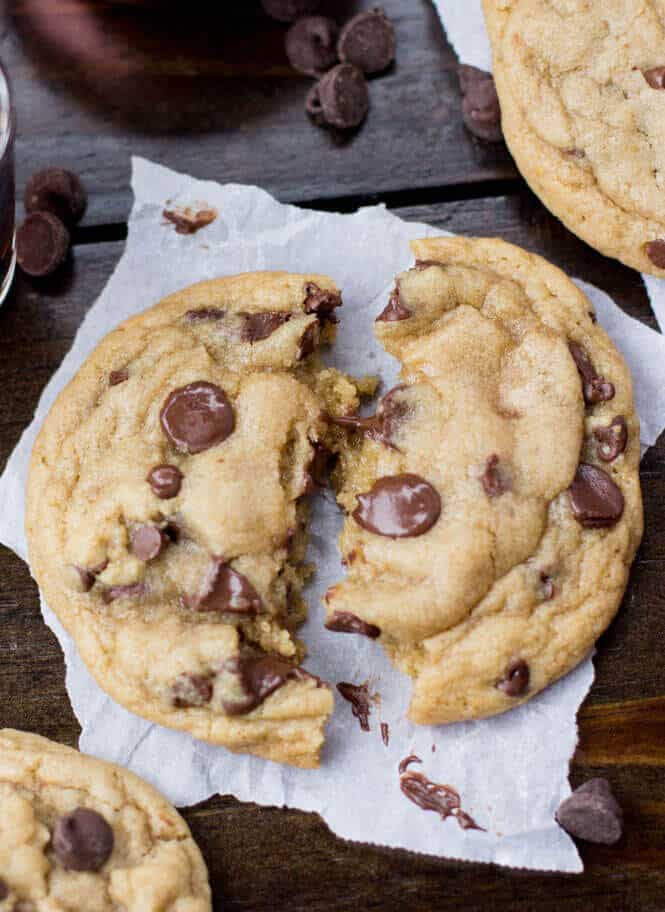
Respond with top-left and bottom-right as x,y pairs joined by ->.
434,0 -> 665,332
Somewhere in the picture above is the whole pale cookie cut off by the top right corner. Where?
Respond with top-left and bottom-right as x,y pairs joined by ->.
483,0 -> 665,276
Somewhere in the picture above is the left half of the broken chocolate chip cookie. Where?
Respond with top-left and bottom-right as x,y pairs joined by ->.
27,273 -> 358,766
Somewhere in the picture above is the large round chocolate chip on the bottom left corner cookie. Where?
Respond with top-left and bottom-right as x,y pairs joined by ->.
52,808 -> 114,871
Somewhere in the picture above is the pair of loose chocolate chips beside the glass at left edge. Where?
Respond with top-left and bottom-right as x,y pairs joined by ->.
16,168 -> 88,278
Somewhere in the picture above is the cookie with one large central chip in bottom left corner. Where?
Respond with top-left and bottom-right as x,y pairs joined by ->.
0,729 -> 212,912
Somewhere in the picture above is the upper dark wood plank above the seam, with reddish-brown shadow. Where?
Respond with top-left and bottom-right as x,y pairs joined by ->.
0,0 -> 515,225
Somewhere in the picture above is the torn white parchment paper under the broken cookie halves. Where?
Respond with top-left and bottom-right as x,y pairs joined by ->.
0,159 -> 665,871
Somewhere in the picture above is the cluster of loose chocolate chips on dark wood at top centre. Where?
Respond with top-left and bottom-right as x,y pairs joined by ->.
263,0 -> 395,130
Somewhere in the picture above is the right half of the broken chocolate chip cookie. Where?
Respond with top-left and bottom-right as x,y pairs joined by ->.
326,238 -> 642,724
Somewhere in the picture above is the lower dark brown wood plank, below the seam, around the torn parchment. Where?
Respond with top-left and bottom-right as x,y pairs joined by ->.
0,193 -> 665,912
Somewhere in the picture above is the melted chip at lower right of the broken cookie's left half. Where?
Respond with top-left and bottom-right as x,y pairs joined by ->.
219,655 -> 312,716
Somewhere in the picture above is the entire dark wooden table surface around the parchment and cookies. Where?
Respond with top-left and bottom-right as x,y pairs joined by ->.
0,0 -> 665,912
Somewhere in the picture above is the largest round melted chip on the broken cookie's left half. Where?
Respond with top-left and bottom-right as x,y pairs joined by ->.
160,380 -> 235,453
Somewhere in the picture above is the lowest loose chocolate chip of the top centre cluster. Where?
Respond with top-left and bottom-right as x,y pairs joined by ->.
306,63 -> 369,130
